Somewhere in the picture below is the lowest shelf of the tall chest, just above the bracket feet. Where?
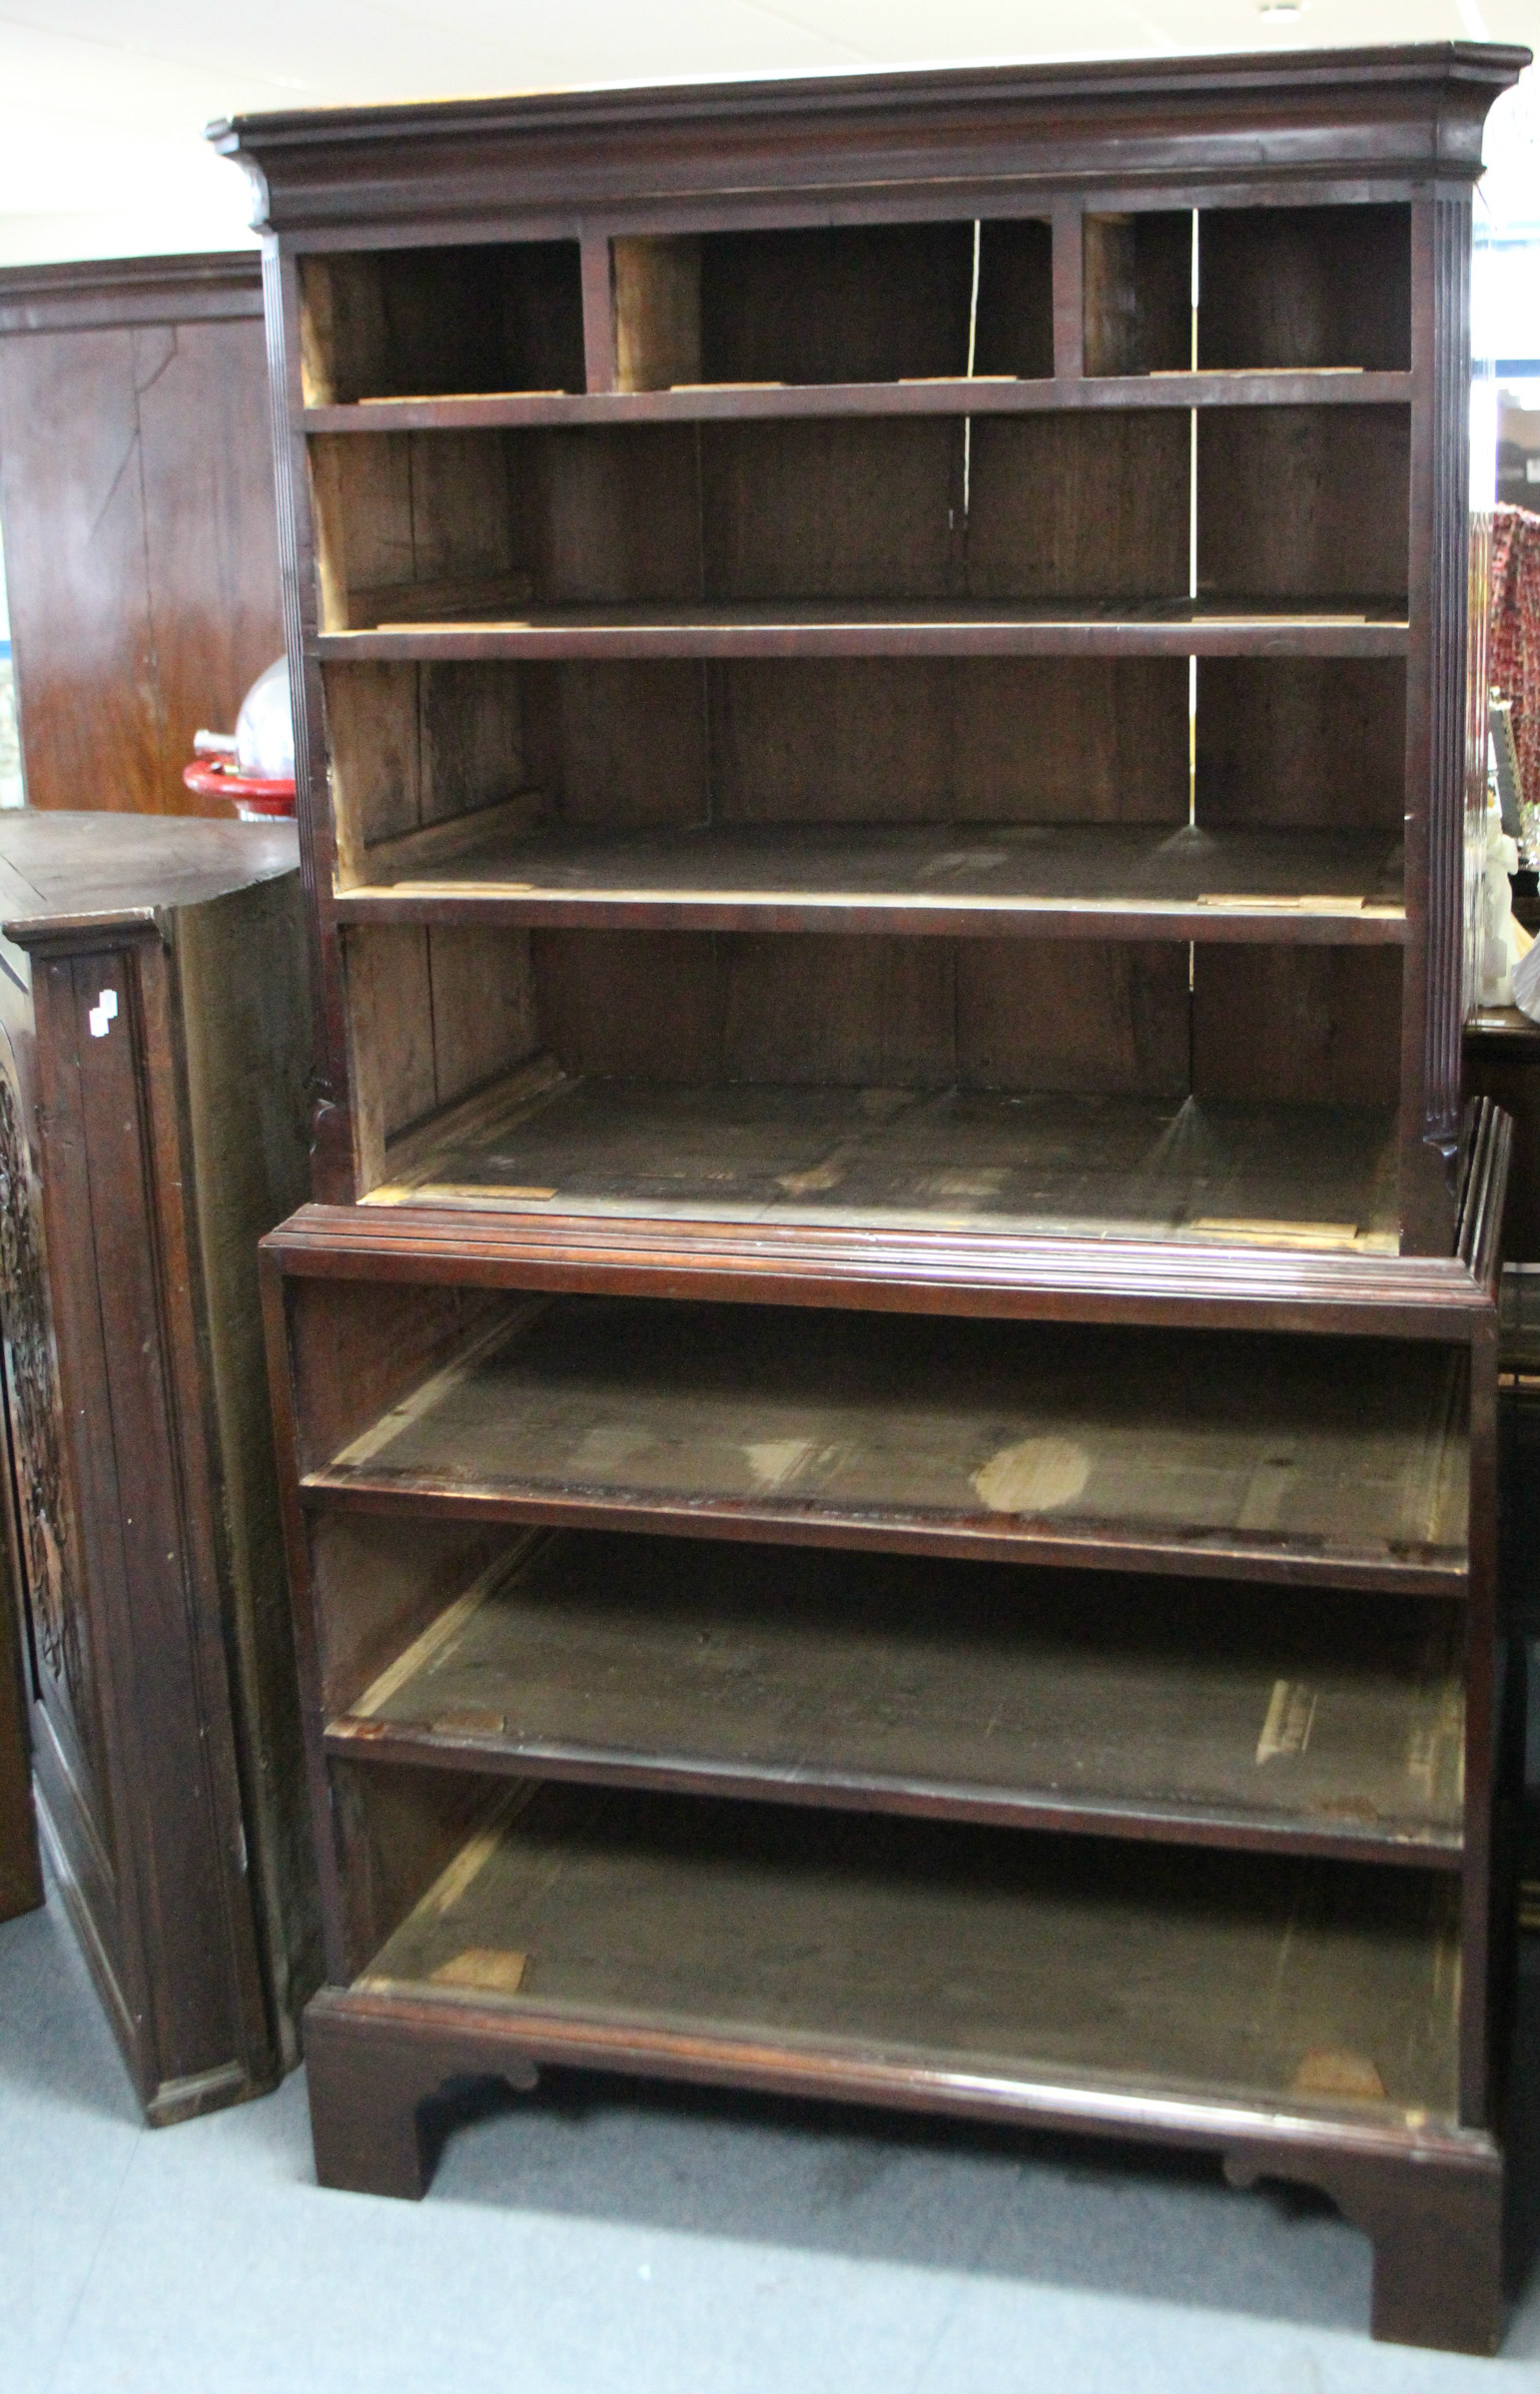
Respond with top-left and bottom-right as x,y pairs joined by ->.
355,1786 -> 1458,2123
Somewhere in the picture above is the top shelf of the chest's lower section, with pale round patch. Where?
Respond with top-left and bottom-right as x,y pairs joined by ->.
302,1297 -> 1468,1597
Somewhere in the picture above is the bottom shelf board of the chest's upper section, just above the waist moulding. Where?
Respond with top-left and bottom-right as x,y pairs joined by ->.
365,1061 -> 1396,1254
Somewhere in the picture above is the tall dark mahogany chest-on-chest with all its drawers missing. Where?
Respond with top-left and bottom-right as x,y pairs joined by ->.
218,46 -> 1523,2348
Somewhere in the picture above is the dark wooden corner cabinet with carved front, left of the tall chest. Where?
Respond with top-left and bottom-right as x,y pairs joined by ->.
0,809 -> 317,2123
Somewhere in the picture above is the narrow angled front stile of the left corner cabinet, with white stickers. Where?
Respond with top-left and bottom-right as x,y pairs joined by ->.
52,941 -> 273,2109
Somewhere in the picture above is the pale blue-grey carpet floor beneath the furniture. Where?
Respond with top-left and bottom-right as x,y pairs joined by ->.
0,1901 -> 1540,2394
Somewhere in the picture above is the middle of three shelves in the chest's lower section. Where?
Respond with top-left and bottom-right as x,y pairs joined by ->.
329,1532 -> 1463,1868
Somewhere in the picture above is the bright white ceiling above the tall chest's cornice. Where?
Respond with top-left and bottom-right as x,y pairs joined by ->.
0,0 -> 1540,264
